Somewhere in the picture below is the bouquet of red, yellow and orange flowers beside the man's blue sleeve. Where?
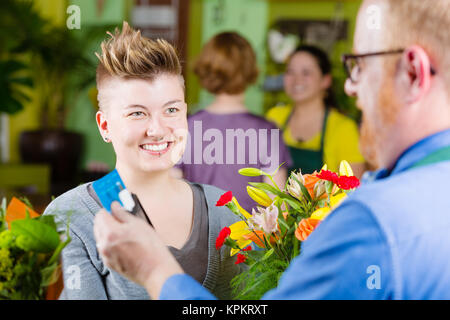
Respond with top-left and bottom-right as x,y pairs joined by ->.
216,161 -> 360,299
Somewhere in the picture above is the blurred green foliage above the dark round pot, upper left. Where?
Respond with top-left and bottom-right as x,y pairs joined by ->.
0,0 -> 111,128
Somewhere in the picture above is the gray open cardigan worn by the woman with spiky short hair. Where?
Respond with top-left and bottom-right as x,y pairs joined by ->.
44,183 -> 241,300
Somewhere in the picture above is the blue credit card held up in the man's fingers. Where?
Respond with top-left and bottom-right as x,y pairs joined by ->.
92,169 -> 125,212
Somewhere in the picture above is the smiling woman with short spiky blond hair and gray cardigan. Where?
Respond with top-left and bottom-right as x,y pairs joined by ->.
45,23 -> 240,299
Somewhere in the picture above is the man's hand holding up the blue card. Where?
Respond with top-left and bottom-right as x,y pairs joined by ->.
94,202 -> 183,299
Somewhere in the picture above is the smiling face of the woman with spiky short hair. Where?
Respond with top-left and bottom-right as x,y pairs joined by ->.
96,74 -> 187,175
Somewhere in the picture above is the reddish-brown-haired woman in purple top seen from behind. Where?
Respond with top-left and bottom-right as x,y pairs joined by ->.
172,32 -> 291,210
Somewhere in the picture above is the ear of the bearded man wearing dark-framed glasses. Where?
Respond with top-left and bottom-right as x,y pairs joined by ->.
402,45 -> 431,103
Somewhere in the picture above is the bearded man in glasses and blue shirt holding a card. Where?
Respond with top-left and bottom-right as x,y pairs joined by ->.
91,0 -> 450,299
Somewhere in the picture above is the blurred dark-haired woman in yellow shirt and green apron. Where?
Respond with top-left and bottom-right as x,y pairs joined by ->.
267,45 -> 365,177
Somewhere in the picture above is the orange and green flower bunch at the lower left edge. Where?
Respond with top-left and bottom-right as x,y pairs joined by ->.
0,198 -> 70,300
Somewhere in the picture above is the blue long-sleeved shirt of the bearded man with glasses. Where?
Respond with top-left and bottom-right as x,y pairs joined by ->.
160,130 -> 450,299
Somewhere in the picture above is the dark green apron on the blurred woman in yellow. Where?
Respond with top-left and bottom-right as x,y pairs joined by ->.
282,108 -> 329,174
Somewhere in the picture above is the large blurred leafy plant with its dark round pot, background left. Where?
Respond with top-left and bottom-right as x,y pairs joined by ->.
0,0 -> 111,195
